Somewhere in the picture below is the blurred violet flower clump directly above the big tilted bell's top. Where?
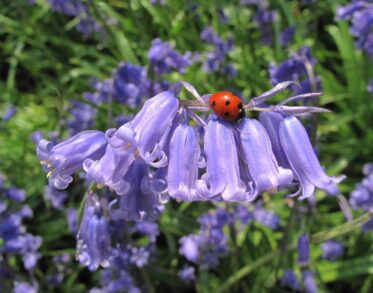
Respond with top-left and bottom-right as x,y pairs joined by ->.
148,39 -> 192,75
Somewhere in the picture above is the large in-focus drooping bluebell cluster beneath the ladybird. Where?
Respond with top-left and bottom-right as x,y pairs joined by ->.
37,82 -> 343,269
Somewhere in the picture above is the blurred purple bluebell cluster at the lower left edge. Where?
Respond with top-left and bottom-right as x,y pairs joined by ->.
0,174 -> 42,292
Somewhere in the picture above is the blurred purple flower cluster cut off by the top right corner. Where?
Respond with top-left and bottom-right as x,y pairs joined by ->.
337,0 -> 373,58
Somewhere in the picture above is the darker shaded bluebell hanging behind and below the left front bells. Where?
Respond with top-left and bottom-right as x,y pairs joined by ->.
109,159 -> 163,221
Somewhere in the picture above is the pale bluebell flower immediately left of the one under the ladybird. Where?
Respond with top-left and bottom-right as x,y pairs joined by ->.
167,123 -> 201,201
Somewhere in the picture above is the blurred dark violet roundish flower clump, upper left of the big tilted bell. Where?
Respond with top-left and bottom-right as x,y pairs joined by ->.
113,63 -> 150,107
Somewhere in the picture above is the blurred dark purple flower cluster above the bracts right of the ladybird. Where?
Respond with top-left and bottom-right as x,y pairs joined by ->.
269,47 -> 321,94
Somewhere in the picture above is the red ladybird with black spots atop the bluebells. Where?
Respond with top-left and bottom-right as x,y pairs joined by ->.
209,92 -> 245,122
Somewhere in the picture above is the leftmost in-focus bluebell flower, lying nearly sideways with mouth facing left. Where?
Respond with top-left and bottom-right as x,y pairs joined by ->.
36,130 -> 107,189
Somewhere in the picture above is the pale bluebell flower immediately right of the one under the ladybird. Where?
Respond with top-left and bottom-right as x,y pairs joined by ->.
239,119 -> 293,200
